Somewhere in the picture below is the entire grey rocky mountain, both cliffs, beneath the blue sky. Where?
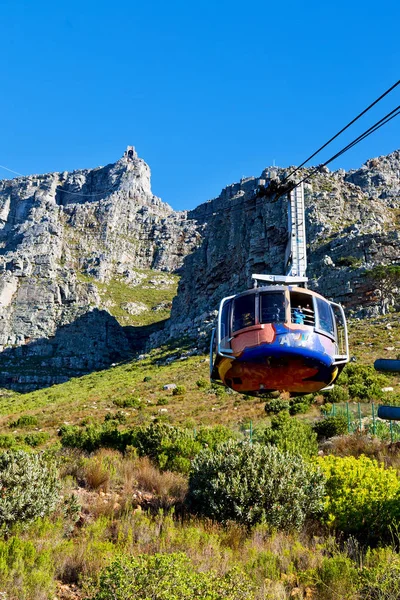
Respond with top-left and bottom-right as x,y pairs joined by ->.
0,151 -> 400,390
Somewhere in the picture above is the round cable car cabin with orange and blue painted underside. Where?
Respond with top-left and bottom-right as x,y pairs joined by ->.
210,276 -> 349,395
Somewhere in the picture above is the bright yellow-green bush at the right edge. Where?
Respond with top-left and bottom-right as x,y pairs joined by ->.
317,455 -> 400,538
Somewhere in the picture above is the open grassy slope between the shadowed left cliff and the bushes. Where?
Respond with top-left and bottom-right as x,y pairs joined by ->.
0,342 -> 265,446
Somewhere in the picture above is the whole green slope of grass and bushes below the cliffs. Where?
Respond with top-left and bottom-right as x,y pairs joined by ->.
0,315 -> 400,600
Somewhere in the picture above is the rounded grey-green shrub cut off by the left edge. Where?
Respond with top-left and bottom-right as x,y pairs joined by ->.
0,450 -> 60,527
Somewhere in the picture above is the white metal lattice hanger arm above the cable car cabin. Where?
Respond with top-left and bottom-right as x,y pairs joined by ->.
286,183 -> 307,277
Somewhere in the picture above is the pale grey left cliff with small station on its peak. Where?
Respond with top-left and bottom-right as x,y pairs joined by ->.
0,148 -> 199,390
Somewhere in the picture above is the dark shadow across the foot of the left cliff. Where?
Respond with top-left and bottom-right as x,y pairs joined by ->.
0,309 -> 166,392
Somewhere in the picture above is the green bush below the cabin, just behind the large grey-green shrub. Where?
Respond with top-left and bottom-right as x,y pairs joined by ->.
263,412 -> 318,458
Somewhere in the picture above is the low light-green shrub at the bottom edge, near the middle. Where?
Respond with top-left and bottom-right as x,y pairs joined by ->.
92,553 -> 254,600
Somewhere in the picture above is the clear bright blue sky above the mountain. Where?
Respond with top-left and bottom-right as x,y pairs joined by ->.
0,0 -> 400,209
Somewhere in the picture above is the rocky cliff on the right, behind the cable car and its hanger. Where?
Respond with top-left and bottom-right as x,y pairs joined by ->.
161,151 -> 400,347
